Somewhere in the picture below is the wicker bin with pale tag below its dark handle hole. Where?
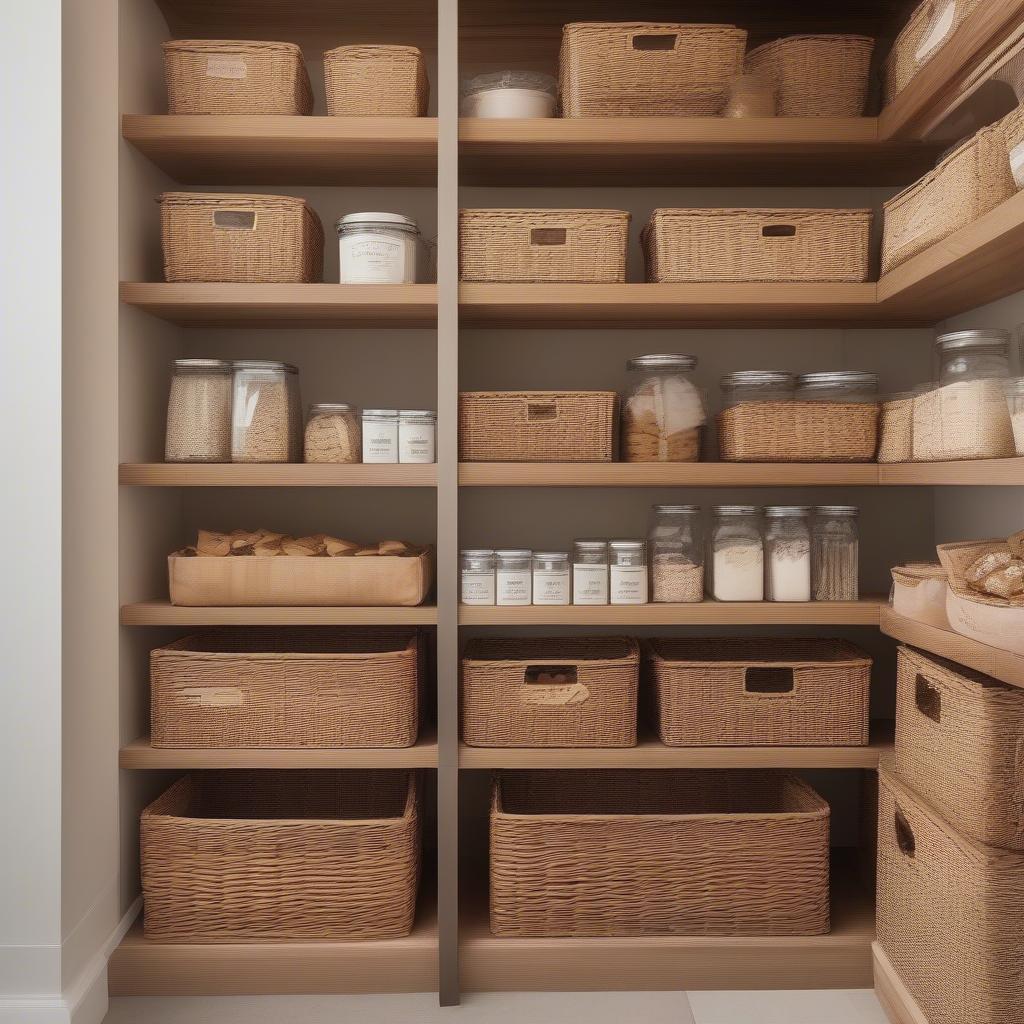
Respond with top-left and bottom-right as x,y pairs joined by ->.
462,637 -> 640,746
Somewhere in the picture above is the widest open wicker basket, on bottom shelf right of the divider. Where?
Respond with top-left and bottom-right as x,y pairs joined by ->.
490,770 -> 828,936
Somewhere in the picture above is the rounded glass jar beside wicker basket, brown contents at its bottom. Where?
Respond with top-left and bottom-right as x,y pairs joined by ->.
622,353 -> 708,462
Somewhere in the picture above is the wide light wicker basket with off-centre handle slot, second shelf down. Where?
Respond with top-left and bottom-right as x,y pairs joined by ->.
640,210 -> 871,283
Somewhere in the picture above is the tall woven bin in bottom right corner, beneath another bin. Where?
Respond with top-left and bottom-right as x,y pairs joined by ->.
877,771 -> 1024,1024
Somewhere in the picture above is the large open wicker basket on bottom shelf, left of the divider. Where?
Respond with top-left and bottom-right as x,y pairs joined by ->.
141,770 -> 420,942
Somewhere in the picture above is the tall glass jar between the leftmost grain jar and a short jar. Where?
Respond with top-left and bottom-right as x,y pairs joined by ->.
231,359 -> 302,462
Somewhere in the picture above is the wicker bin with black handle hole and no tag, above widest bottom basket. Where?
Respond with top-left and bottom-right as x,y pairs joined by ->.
647,637 -> 871,746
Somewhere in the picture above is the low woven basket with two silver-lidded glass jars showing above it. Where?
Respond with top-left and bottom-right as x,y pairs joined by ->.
718,401 -> 879,462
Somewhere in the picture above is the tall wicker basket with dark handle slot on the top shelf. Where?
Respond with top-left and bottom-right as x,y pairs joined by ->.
559,22 -> 746,118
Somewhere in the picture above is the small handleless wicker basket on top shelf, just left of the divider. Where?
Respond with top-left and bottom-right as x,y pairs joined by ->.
324,46 -> 430,118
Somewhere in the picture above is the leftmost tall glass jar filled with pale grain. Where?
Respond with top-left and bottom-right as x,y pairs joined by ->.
164,359 -> 231,462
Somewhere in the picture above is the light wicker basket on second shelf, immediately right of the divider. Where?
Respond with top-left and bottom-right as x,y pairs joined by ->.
459,210 -> 630,284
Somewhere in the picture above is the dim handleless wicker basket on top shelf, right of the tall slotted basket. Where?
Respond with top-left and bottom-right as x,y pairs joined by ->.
744,36 -> 874,118
